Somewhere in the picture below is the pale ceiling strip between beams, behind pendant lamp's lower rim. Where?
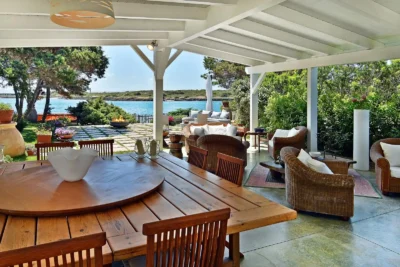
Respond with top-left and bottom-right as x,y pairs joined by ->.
0,15 -> 185,32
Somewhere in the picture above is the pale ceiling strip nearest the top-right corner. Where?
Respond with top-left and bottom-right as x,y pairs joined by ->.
338,0 -> 400,27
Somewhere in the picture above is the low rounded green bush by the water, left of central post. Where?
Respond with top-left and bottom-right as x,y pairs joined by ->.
67,97 -> 136,125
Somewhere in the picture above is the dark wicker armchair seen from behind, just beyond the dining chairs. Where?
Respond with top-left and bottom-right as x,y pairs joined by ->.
197,134 -> 250,173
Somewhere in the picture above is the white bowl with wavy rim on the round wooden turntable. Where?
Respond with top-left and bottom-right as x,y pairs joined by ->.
47,148 -> 98,182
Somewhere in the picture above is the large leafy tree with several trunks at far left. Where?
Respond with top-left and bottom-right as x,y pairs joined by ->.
0,47 -> 109,120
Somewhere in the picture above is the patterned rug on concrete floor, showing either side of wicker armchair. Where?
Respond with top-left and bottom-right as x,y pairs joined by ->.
245,164 -> 382,198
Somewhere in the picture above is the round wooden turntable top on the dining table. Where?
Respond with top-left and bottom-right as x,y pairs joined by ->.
0,160 -> 165,216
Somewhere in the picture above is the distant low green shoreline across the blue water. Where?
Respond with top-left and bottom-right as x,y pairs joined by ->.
76,90 -> 232,101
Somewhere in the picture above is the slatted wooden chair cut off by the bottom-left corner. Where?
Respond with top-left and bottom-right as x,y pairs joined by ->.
0,233 -> 106,267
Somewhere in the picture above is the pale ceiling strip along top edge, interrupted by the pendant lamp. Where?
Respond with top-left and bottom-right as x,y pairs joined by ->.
0,0 -> 208,20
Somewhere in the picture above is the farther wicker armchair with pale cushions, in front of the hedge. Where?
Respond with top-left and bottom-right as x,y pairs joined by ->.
268,126 -> 308,159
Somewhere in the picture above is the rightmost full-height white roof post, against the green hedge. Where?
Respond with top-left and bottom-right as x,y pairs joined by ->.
307,68 -> 318,151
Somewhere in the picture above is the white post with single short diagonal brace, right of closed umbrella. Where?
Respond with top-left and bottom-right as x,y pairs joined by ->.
250,73 -> 265,147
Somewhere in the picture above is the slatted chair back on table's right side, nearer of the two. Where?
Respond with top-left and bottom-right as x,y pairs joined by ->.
215,153 -> 245,186
